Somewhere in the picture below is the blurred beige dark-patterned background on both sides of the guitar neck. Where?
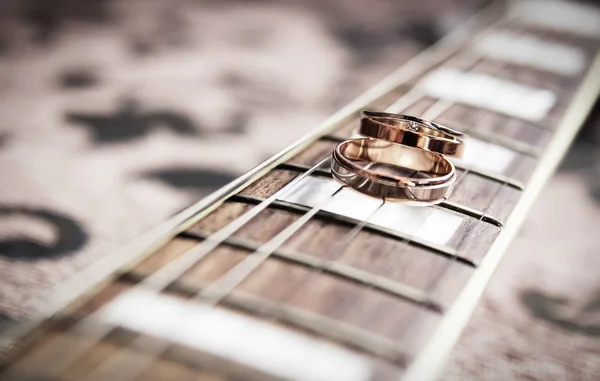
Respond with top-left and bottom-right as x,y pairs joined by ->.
0,0 -> 600,380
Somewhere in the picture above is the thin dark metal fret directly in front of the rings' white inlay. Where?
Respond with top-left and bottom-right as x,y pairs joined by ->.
228,195 -> 477,267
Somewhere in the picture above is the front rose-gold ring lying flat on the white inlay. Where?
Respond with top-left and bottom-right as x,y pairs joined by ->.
331,138 -> 456,204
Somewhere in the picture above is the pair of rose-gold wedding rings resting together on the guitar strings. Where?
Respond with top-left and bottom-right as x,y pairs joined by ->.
331,111 -> 464,205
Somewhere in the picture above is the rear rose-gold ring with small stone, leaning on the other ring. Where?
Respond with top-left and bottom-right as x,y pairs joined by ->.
358,111 -> 464,158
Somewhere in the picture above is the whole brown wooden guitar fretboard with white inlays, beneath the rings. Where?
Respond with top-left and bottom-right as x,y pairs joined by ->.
0,1 -> 600,381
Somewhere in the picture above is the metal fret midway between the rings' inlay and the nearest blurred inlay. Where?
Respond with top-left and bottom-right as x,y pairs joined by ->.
180,231 -> 444,313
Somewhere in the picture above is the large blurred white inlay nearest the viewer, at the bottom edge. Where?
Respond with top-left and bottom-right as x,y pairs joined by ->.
101,290 -> 371,381
